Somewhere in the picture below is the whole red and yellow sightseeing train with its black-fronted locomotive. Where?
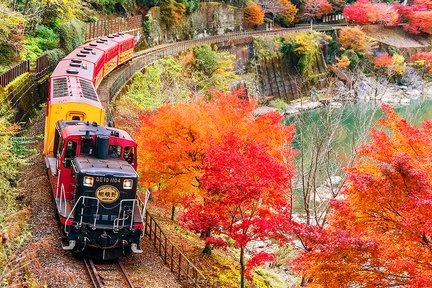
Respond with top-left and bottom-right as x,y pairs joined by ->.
43,33 -> 144,260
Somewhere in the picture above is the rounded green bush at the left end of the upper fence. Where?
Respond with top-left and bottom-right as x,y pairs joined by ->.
58,20 -> 85,53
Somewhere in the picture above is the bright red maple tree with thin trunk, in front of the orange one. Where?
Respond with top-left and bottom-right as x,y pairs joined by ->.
182,134 -> 293,287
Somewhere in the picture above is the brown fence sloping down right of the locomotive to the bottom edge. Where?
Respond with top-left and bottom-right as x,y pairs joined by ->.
144,211 -> 208,288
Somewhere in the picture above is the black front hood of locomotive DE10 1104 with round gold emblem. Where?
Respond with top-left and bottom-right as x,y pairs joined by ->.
65,156 -> 143,259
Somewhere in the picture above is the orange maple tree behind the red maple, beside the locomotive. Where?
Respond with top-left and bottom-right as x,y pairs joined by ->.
136,92 -> 293,206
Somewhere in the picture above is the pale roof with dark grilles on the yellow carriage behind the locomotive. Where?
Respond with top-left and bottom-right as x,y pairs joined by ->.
50,76 -> 102,108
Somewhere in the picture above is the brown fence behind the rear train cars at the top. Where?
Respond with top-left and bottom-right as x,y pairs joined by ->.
85,15 -> 143,41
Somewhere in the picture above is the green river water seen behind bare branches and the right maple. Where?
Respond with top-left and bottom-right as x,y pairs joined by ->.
285,98 -> 432,210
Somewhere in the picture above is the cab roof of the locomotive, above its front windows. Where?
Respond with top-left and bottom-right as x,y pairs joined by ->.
56,120 -> 134,141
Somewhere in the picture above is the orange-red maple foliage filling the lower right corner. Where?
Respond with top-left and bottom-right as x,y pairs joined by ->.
293,105 -> 432,287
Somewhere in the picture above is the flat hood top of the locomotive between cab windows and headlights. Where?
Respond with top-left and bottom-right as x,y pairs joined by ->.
74,156 -> 138,178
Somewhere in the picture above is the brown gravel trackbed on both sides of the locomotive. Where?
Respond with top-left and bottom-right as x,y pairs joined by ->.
21,110 -> 180,288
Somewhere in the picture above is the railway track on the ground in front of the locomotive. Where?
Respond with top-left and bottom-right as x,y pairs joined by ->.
83,258 -> 134,288
